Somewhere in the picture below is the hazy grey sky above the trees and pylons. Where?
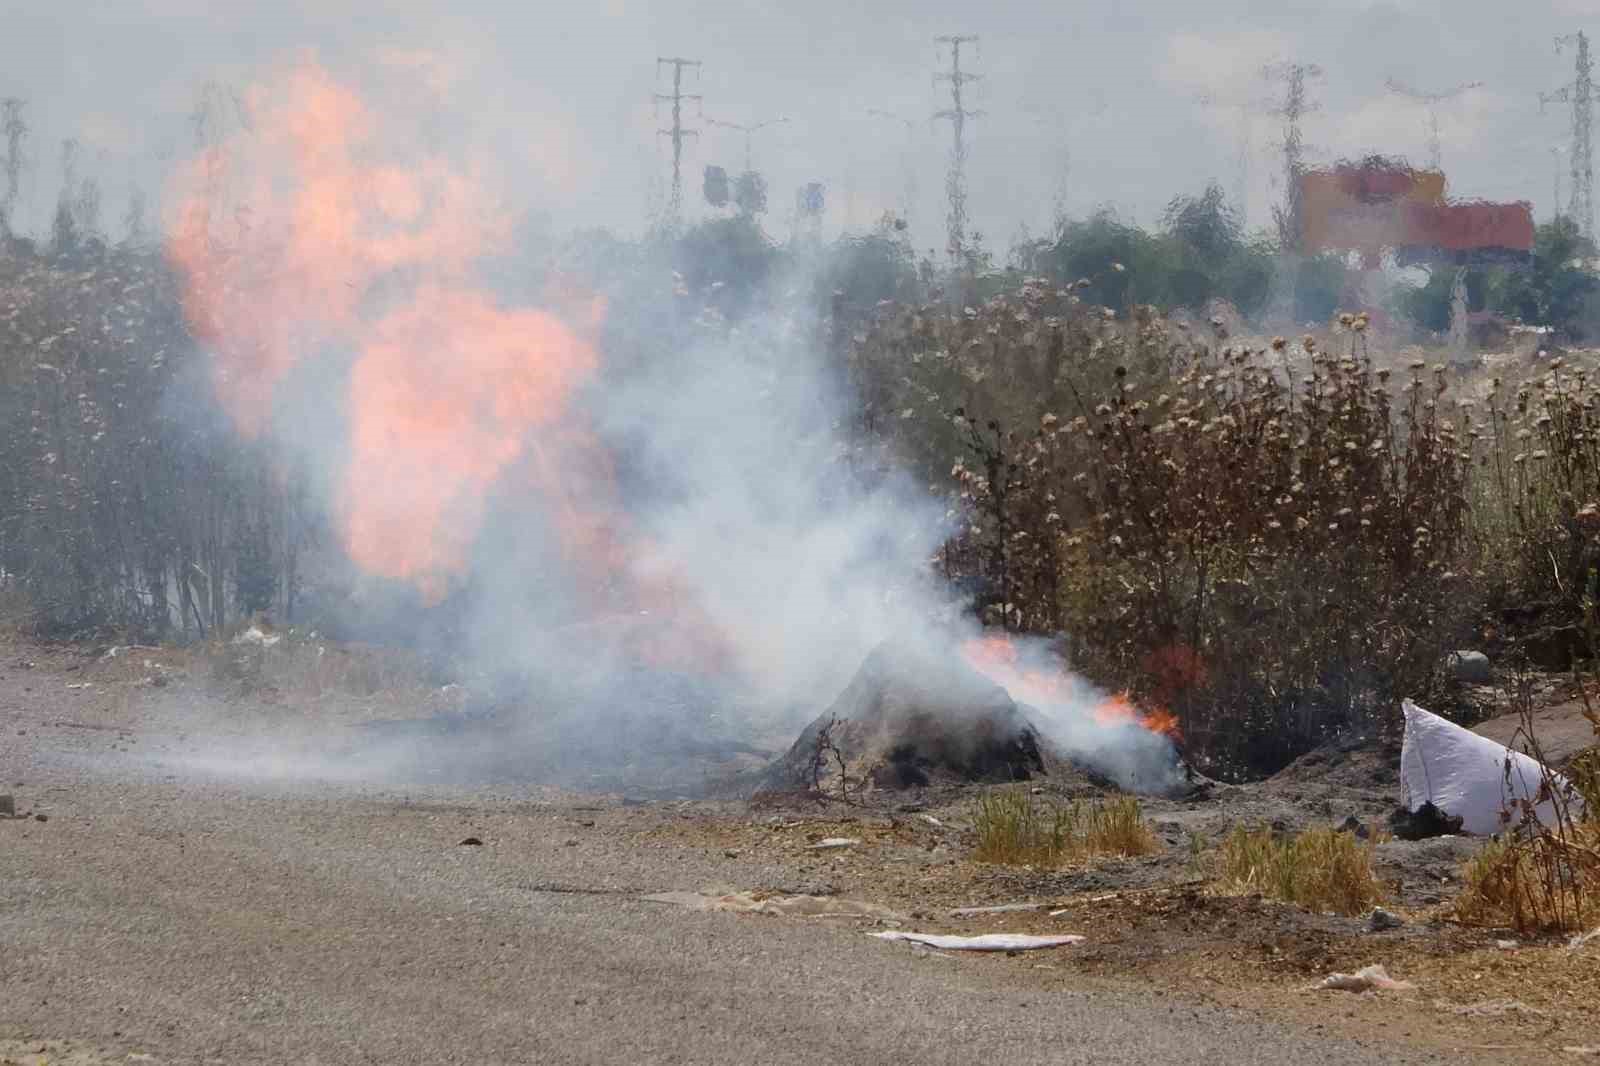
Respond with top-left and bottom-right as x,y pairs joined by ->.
9,0 -> 1600,253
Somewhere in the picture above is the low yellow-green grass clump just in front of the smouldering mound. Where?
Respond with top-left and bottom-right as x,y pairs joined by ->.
973,789 -> 1157,866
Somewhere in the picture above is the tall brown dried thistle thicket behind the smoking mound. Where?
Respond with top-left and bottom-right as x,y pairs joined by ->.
862,288 -> 1474,778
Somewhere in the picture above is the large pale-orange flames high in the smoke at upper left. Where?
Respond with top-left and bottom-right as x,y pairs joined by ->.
171,59 -> 622,599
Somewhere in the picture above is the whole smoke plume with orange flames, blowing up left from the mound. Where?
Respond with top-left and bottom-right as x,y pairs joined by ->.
170,58 -> 1173,793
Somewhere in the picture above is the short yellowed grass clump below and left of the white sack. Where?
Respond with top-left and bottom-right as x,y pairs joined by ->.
1221,826 -> 1382,914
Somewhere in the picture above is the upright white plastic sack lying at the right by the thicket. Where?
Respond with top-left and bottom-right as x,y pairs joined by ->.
1400,699 -> 1582,836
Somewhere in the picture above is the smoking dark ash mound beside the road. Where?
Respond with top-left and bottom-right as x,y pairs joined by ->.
765,633 -> 1045,792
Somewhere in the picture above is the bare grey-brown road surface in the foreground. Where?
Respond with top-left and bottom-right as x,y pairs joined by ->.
0,650 -> 1472,1066
